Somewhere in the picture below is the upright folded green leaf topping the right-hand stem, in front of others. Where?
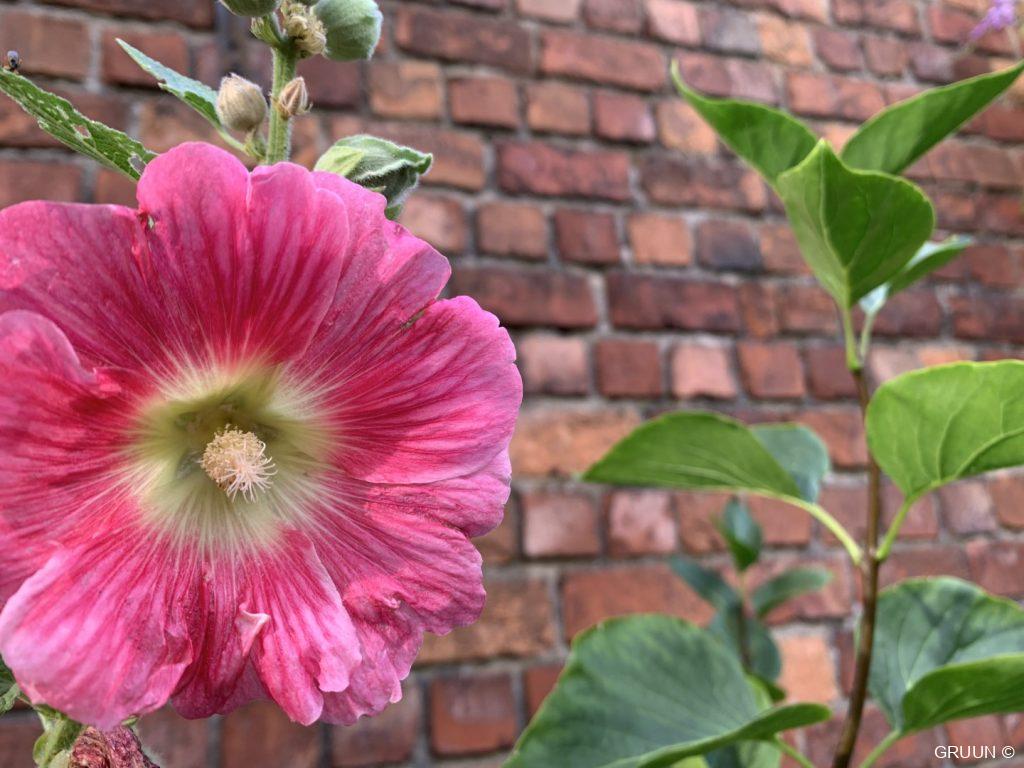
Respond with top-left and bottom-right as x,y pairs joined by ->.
778,141 -> 935,308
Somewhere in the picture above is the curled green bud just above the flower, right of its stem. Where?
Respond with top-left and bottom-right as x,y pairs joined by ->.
315,135 -> 434,219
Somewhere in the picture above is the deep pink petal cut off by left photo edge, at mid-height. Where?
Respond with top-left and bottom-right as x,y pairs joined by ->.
0,311 -> 130,604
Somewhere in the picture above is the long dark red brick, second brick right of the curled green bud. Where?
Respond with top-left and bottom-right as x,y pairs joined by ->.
498,142 -> 630,201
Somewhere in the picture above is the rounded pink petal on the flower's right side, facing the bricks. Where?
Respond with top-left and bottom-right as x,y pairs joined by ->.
311,297 -> 522,483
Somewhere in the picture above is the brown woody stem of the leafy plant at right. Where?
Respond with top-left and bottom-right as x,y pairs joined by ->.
833,366 -> 882,768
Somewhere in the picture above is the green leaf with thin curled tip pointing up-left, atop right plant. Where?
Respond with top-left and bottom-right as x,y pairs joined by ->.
672,61 -> 818,184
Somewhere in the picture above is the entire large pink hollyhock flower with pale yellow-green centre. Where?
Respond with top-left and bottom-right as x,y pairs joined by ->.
0,144 -> 521,728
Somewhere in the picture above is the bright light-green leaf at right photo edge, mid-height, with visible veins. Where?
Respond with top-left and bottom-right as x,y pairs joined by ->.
866,360 -> 1024,499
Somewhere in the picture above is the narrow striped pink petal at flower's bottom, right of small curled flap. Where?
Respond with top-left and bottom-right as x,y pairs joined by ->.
241,532 -> 361,725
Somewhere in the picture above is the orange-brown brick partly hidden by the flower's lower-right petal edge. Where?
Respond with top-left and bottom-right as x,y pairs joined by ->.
417,579 -> 555,665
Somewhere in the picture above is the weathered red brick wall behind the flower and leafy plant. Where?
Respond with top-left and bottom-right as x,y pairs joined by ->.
0,0 -> 1024,768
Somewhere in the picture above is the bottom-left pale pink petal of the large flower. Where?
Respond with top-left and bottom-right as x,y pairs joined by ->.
0,528 -> 195,729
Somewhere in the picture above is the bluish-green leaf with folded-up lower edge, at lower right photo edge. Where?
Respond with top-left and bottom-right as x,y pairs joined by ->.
868,578 -> 1024,733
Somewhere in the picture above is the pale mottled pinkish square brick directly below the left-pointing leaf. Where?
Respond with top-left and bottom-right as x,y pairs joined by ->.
608,490 -> 679,557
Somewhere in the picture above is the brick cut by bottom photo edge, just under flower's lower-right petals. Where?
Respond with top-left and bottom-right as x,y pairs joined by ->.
331,682 -> 423,768
